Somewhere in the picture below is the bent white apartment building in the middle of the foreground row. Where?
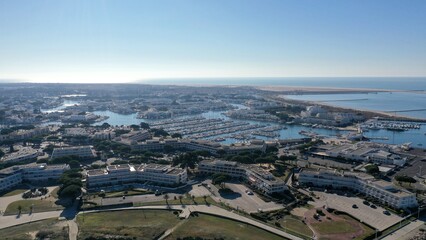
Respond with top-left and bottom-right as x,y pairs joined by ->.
198,160 -> 287,194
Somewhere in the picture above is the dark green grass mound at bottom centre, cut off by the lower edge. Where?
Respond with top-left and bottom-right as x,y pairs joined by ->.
167,214 -> 284,240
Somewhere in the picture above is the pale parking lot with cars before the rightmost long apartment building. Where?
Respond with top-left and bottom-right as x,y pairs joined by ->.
313,191 -> 402,230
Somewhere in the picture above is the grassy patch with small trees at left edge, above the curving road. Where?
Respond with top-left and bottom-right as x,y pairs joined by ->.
4,199 -> 64,215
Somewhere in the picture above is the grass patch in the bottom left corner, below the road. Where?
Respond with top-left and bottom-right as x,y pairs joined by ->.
0,218 -> 68,240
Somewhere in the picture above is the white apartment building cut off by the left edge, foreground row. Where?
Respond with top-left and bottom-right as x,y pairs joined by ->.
0,163 -> 70,191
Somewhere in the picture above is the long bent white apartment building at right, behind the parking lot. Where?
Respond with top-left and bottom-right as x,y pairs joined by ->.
299,169 -> 418,209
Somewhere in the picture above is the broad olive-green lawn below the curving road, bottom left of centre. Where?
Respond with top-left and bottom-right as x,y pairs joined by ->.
77,210 -> 181,239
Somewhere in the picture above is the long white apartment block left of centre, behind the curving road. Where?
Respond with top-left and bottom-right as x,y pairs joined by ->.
86,164 -> 188,189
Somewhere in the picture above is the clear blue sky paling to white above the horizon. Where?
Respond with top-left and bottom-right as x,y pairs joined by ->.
0,0 -> 426,82
